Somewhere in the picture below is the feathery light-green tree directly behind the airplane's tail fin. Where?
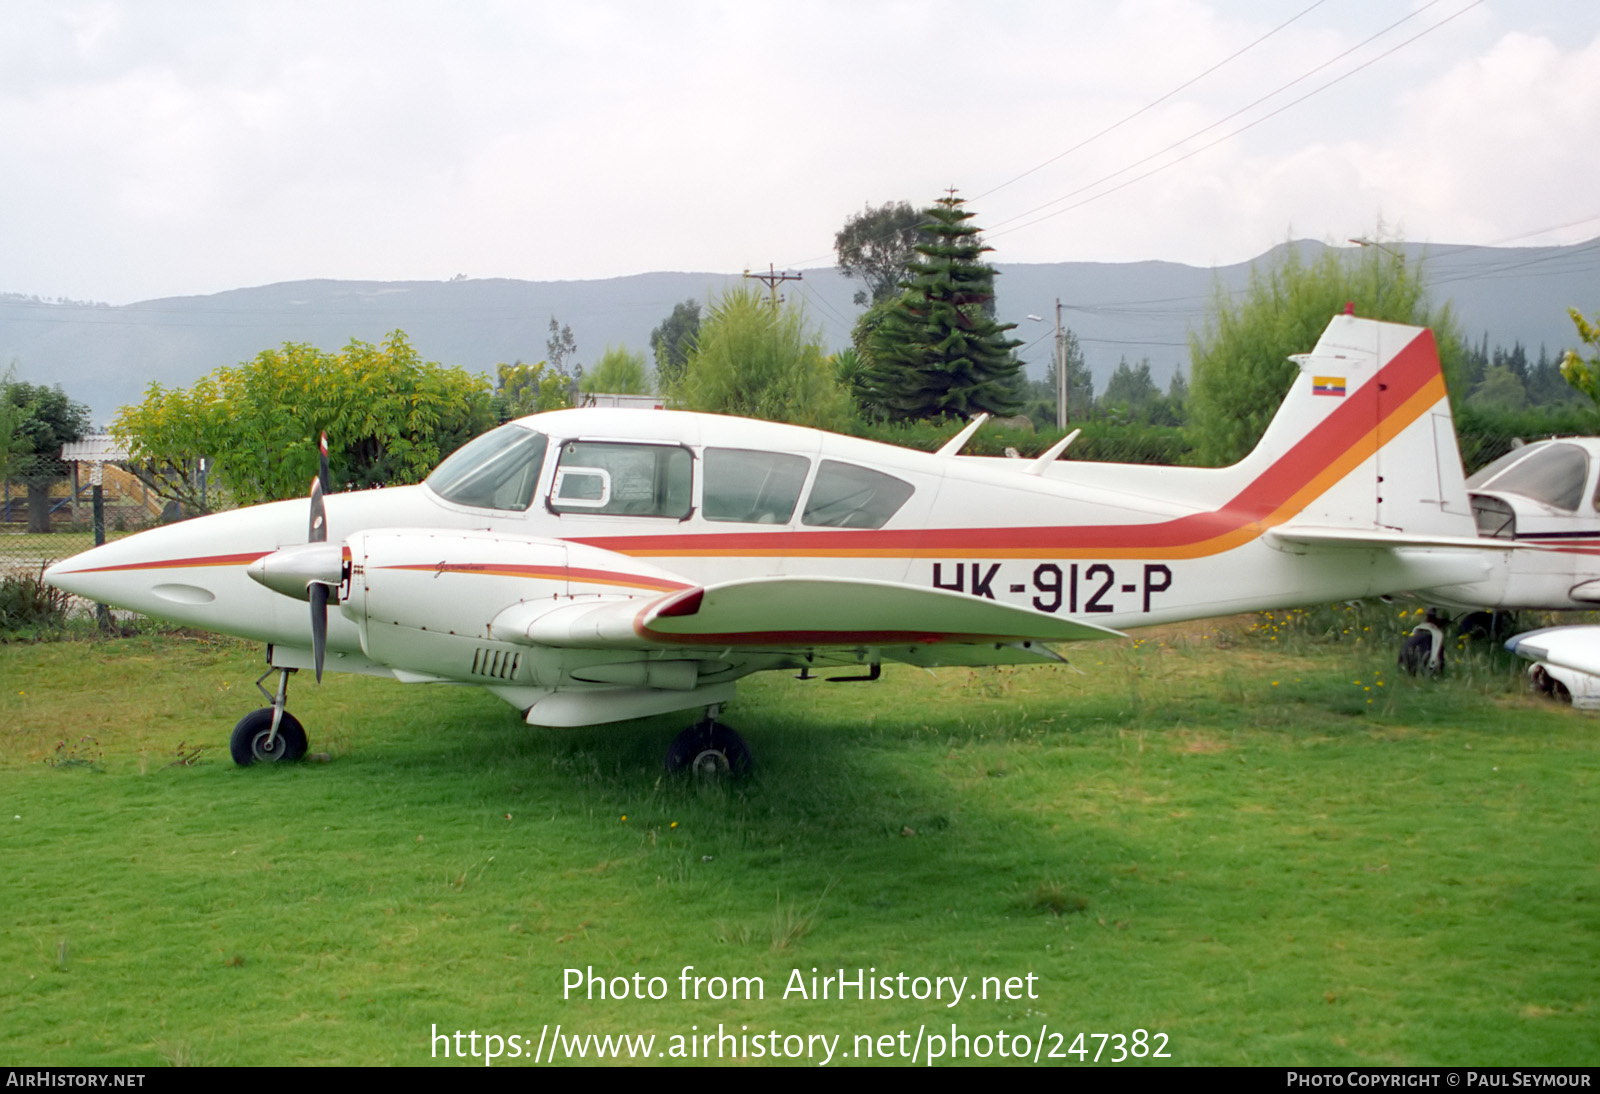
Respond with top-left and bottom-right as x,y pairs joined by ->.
1189,243 -> 1466,465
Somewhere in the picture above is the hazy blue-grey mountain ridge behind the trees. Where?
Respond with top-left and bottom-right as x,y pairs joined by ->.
0,238 -> 1600,422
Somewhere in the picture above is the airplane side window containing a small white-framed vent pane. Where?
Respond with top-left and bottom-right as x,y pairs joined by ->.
549,441 -> 693,520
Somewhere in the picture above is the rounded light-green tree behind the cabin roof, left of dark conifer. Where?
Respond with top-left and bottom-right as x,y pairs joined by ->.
667,285 -> 851,429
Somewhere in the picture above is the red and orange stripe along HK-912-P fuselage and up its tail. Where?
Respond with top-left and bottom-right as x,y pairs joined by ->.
574,331 -> 1445,558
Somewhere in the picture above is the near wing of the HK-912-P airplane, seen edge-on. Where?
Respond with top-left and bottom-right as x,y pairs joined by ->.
490,577 -> 1122,652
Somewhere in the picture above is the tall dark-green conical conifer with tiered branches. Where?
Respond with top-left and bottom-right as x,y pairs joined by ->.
866,190 -> 1022,419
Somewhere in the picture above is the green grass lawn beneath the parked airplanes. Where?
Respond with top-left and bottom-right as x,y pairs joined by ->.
0,608 -> 1600,1065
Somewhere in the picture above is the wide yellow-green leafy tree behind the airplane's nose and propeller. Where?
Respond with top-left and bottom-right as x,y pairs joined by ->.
112,331 -> 494,507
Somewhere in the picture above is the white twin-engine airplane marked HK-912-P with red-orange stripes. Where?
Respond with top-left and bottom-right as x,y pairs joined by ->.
46,315 -> 1490,769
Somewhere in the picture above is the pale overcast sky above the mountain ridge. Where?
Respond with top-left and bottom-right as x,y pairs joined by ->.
0,0 -> 1600,304
